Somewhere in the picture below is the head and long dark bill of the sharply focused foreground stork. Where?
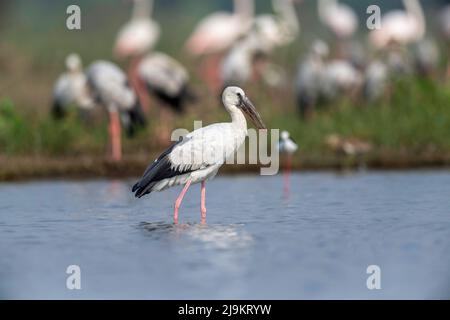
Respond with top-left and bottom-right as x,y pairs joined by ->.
222,87 -> 267,129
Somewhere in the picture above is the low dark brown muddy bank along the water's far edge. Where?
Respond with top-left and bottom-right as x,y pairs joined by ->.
0,152 -> 450,181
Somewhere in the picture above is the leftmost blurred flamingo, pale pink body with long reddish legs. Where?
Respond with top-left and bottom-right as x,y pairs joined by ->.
114,0 -> 161,111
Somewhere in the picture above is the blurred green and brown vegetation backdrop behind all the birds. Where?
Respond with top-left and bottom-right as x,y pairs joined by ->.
0,0 -> 450,176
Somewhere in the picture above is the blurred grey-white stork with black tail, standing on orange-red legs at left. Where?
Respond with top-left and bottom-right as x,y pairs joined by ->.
86,61 -> 145,161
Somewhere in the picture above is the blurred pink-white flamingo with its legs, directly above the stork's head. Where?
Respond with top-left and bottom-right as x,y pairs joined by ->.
185,0 -> 254,92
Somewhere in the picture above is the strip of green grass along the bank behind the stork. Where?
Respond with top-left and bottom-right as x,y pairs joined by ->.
0,75 -> 450,160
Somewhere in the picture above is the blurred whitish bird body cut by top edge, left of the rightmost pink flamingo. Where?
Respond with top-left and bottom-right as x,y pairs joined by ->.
318,0 -> 358,39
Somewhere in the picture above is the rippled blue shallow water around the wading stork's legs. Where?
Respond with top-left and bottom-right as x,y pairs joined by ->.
0,171 -> 450,299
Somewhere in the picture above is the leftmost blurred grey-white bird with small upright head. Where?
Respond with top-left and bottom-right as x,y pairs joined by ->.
52,53 -> 95,119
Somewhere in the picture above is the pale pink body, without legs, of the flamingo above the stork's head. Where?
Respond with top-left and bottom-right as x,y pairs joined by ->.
186,0 -> 254,56
